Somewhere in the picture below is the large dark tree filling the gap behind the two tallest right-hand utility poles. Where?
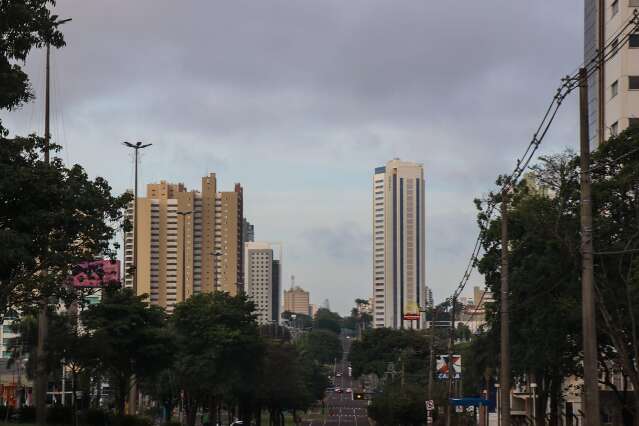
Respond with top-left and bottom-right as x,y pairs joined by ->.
476,152 -> 581,424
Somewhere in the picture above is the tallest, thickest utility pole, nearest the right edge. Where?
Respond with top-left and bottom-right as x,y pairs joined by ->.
579,68 -> 600,426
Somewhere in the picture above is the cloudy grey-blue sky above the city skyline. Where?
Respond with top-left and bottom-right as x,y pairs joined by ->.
3,0 -> 583,313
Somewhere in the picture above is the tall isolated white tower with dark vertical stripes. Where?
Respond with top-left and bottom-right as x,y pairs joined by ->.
373,159 -> 427,328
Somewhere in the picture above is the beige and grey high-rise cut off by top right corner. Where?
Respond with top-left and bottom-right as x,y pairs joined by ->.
584,0 -> 639,147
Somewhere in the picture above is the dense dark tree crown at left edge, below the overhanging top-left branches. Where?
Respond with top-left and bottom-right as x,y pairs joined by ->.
0,137 -> 130,314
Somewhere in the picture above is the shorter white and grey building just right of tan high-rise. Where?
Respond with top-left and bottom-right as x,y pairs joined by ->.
244,242 -> 280,324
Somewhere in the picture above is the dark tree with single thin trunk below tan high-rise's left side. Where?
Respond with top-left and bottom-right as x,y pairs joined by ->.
81,286 -> 175,416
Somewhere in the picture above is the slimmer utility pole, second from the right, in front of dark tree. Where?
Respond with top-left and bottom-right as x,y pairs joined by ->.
499,188 -> 510,426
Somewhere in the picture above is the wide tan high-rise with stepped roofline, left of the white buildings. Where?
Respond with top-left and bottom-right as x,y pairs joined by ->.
124,173 -> 243,312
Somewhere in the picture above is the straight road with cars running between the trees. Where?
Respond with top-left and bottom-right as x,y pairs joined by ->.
302,339 -> 371,426
